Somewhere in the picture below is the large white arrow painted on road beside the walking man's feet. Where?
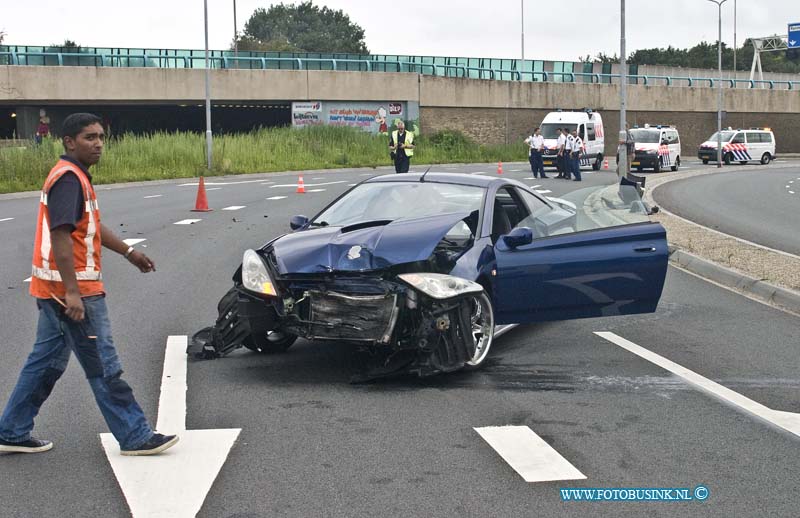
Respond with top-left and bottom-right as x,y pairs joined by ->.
100,336 -> 241,518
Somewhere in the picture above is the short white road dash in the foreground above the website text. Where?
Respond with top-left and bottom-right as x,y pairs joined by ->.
474,426 -> 586,482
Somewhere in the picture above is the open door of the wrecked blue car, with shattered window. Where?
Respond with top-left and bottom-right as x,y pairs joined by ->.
492,186 -> 668,324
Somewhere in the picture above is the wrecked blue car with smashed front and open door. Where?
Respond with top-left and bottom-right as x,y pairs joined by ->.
194,173 -> 667,378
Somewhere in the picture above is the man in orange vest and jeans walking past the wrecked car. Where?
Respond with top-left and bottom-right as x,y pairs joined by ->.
0,113 -> 178,455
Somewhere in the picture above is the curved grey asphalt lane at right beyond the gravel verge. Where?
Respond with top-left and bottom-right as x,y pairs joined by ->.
653,162 -> 800,255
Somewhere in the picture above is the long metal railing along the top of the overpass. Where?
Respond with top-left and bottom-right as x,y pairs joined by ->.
0,50 -> 800,90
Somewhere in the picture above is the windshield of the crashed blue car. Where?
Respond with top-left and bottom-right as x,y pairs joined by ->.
311,182 -> 485,226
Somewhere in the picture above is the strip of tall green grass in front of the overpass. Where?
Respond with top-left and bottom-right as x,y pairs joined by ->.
0,126 -> 527,193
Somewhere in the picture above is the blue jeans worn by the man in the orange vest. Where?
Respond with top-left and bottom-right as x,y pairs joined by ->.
0,295 -> 153,450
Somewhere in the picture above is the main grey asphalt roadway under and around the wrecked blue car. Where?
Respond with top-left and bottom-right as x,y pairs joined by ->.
0,165 -> 800,518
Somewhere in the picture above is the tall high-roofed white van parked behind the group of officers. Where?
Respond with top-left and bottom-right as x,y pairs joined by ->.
539,108 -> 605,171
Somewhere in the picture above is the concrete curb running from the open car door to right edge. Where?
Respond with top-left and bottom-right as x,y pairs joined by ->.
669,245 -> 800,315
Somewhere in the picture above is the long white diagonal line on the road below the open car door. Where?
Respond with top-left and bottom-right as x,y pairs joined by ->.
595,331 -> 800,437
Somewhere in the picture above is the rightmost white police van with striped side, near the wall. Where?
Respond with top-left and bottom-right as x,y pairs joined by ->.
697,128 -> 775,165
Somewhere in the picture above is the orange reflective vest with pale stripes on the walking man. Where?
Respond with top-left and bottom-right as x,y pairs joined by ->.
30,160 -> 104,299
